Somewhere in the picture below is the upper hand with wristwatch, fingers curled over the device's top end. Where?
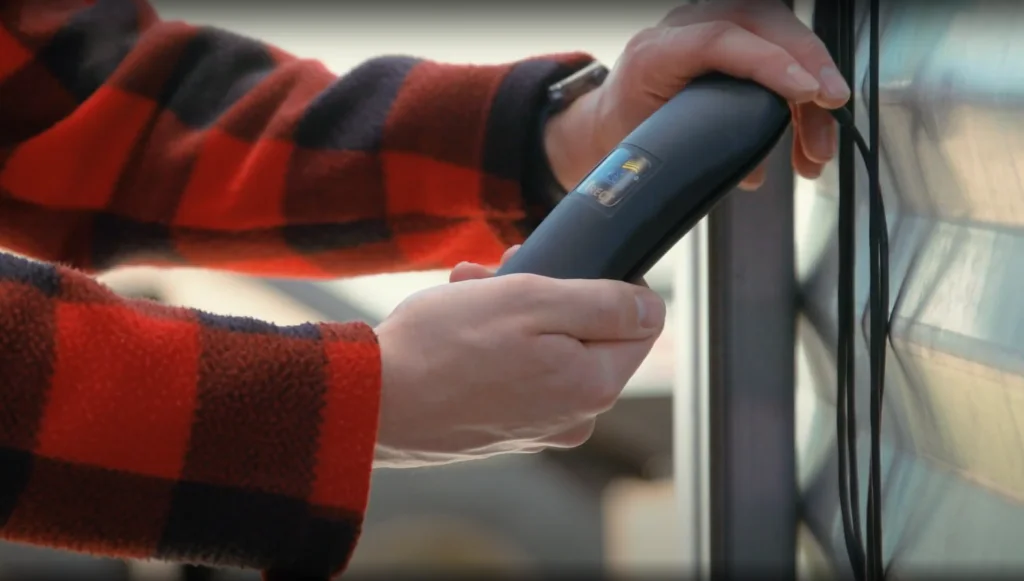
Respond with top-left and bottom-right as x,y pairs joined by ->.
545,0 -> 850,190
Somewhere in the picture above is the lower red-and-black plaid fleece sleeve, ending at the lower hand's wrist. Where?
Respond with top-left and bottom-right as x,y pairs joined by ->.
0,254 -> 380,577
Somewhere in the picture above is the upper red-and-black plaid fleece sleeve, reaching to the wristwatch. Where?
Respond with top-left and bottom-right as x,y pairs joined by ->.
0,0 -> 589,278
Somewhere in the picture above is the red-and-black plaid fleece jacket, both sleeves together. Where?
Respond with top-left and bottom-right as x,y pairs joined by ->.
0,0 -> 589,579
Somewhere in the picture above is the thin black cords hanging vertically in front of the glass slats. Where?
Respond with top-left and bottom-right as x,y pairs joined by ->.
819,0 -> 889,581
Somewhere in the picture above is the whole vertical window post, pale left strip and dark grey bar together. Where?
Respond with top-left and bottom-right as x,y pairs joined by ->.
674,134 -> 798,579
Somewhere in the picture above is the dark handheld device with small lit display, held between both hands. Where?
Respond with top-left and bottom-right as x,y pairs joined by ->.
498,74 -> 791,281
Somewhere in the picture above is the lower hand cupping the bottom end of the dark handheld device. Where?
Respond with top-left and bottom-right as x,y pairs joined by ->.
375,248 -> 666,467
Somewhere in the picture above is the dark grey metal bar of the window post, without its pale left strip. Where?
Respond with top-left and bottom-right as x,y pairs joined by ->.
708,122 -> 798,579
